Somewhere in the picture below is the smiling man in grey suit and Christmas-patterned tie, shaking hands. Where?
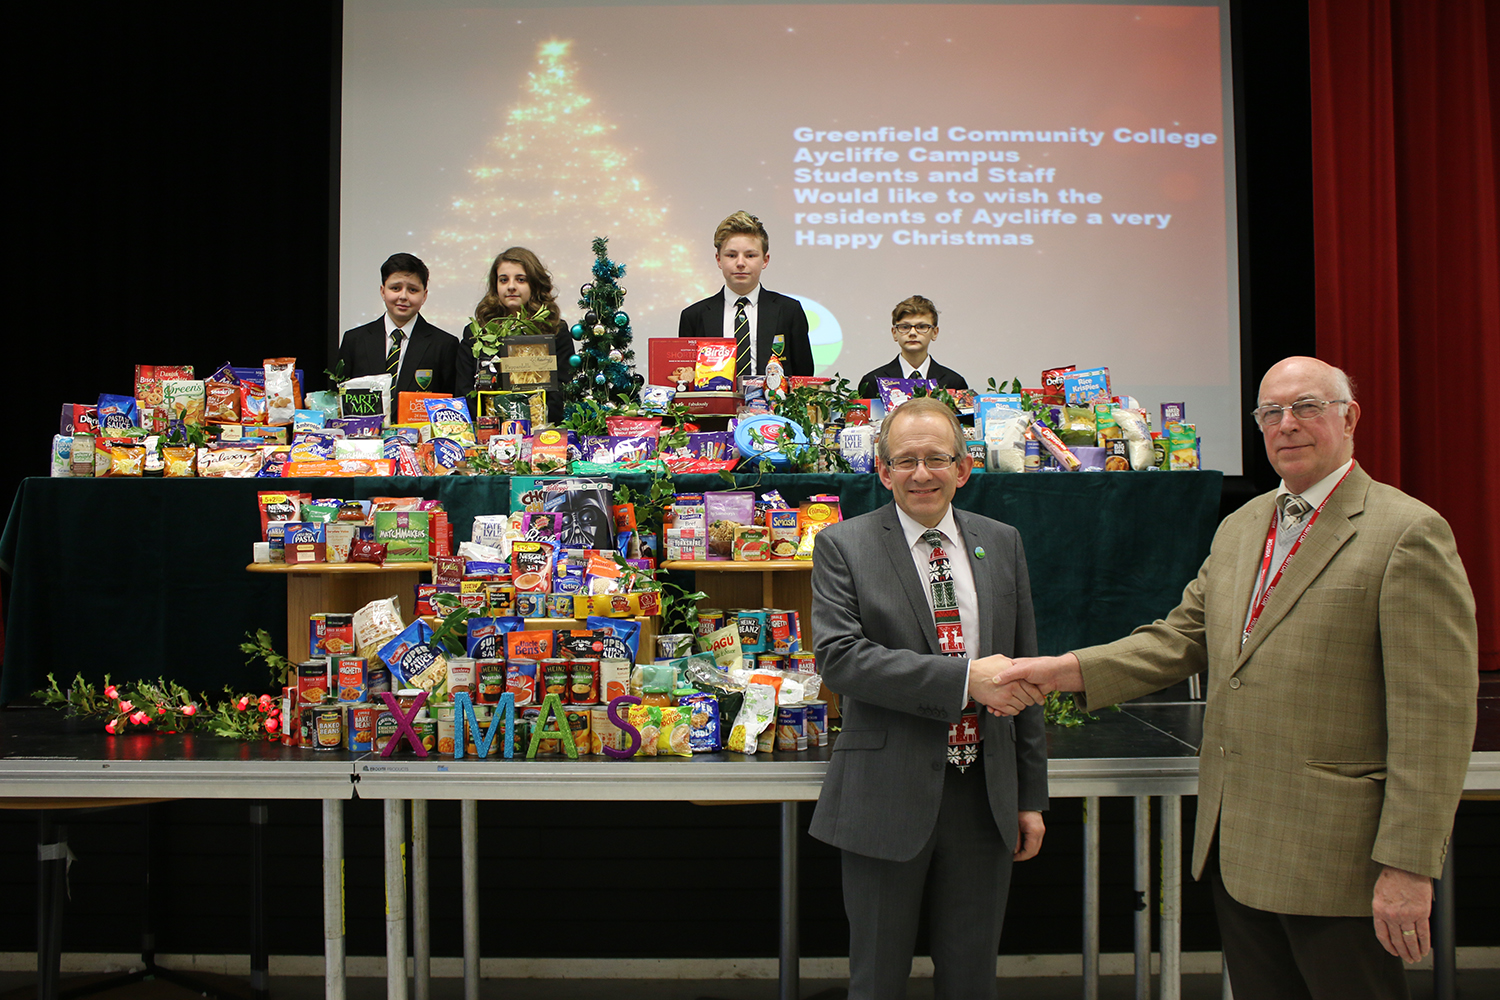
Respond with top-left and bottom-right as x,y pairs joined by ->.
810,399 -> 1047,1000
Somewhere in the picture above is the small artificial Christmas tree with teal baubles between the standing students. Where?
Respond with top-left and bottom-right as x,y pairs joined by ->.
567,237 -> 641,406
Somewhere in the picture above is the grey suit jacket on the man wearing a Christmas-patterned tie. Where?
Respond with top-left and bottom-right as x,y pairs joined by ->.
810,504 -> 1047,861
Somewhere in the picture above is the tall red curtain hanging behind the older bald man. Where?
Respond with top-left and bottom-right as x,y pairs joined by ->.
1308,0 -> 1500,670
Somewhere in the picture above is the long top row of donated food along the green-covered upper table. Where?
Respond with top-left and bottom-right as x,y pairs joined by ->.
51,358 -> 1200,478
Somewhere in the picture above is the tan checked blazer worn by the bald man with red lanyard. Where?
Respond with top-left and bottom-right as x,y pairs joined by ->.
1077,465 -> 1479,916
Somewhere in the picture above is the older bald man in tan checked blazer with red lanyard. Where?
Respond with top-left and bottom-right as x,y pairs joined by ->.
998,358 -> 1478,1000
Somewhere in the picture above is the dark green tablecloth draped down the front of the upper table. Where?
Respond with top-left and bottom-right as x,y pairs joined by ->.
0,472 -> 1223,703
